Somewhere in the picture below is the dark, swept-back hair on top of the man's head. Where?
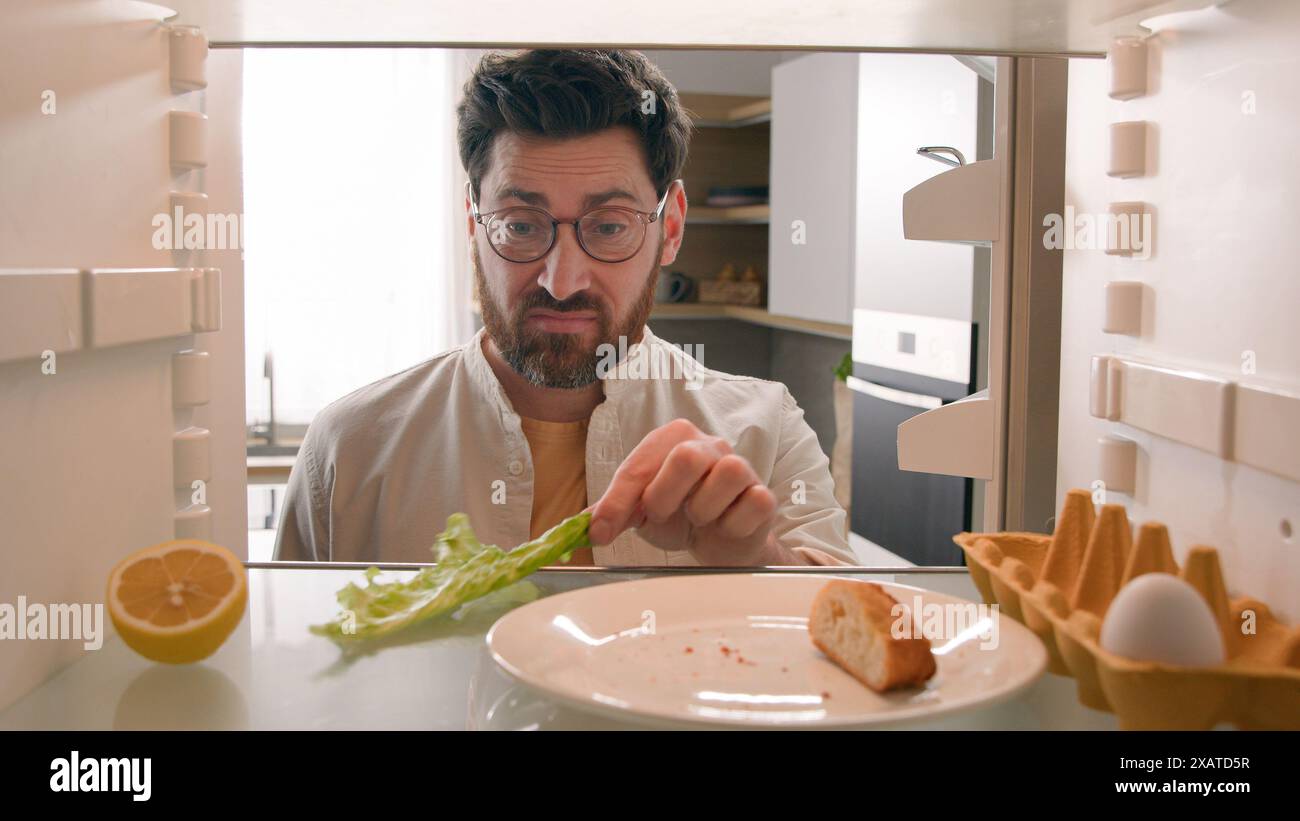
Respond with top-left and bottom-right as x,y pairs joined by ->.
456,48 -> 692,203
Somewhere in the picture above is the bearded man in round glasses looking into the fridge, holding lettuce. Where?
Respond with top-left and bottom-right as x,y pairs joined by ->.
276,51 -> 854,565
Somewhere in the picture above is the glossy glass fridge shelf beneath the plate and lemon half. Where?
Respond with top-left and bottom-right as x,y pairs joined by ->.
0,564 -> 1117,730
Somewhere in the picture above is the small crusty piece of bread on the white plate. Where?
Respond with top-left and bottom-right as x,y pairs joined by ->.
809,579 -> 936,692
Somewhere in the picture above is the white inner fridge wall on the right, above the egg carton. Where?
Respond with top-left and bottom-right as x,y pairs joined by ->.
1057,0 -> 1300,621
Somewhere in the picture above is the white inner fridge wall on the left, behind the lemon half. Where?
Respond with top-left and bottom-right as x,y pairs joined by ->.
0,0 -> 247,708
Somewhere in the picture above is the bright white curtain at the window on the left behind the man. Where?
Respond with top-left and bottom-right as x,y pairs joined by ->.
243,48 -> 481,423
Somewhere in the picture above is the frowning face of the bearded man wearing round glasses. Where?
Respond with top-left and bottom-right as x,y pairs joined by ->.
465,127 -> 685,388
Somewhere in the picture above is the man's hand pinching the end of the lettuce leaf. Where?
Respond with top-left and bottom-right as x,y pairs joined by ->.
589,420 -> 803,565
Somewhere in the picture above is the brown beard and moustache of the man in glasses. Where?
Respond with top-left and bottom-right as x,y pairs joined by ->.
471,236 -> 663,390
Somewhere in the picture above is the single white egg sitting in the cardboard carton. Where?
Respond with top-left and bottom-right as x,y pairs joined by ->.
1101,573 -> 1225,666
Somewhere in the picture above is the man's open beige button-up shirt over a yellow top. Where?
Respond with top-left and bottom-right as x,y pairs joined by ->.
274,327 -> 857,566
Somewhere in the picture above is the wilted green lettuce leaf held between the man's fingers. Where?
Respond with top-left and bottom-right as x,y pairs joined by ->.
311,511 -> 592,642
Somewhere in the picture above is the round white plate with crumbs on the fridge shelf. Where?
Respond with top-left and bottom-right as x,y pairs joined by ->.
488,573 -> 1048,727
